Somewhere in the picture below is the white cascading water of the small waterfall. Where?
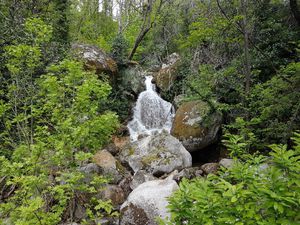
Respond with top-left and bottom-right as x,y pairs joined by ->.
127,76 -> 174,141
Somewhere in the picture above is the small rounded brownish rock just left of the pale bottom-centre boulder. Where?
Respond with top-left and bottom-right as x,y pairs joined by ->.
100,185 -> 125,206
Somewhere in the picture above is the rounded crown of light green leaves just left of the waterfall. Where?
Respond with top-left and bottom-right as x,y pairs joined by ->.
36,60 -> 118,154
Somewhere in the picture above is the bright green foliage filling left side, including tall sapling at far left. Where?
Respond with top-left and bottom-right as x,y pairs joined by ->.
0,18 -> 118,222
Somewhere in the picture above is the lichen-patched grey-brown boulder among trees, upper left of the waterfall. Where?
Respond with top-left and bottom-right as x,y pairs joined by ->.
72,44 -> 118,76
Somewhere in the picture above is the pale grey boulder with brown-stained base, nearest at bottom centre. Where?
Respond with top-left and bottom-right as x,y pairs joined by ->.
120,179 -> 178,225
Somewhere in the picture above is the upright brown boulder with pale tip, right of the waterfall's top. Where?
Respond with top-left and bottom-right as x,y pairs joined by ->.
154,53 -> 180,91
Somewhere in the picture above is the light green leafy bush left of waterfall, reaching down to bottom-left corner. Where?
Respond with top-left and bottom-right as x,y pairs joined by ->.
0,60 -> 118,225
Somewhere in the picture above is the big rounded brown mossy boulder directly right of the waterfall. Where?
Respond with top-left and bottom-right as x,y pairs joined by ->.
171,101 -> 222,152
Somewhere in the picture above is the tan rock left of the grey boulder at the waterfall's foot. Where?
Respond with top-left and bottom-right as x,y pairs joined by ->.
93,150 -> 128,184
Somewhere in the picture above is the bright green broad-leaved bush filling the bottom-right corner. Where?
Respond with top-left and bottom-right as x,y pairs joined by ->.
166,134 -> 300,224
